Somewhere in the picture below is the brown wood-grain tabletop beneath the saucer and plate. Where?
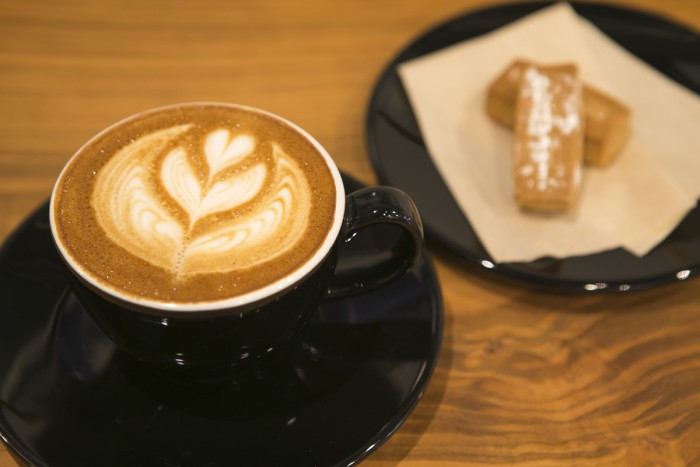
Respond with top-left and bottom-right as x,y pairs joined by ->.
0,0 -> 700,467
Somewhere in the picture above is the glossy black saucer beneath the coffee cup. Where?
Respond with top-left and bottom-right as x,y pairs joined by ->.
0,174 -> 443,467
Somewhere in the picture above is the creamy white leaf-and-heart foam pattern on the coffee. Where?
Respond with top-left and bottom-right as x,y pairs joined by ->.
91,125 -> 311,279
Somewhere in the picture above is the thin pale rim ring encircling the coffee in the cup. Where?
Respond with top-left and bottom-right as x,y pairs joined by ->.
49,101 -> 345,313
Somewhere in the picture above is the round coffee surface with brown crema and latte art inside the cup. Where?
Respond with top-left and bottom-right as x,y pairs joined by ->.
52,104 -> 337,303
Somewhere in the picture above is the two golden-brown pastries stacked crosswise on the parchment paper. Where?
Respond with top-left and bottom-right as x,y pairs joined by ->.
486,60 -> 631,213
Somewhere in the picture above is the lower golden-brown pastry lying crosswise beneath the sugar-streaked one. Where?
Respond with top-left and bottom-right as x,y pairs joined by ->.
486,60 -> 631,167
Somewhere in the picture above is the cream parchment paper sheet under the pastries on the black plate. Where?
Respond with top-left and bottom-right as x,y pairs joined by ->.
399,3 -> 700,262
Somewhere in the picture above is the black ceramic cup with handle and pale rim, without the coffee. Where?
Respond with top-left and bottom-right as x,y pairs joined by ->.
50,104 -> 423,380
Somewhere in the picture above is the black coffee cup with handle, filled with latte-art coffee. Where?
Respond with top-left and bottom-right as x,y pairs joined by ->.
50,103 -> 423,379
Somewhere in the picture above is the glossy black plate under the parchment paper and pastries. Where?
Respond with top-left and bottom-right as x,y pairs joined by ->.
366,3 -> 700,291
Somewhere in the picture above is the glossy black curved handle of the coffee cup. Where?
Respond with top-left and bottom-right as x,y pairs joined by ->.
328,186 -> 423,298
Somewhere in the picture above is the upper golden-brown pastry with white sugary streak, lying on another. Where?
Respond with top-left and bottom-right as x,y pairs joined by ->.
513,65 -> 585,212
